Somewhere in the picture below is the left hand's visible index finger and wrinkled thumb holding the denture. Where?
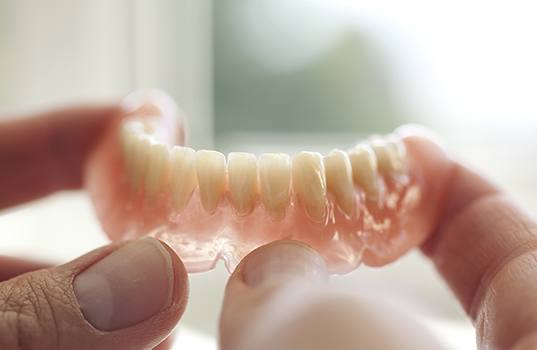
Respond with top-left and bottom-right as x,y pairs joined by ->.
0,106 -> 188,349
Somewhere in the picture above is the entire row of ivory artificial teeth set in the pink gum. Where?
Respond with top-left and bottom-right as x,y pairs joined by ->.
122,123 -> 406,220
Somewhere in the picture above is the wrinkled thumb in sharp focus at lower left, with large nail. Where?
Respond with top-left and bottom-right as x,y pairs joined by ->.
0,238 -> 188,349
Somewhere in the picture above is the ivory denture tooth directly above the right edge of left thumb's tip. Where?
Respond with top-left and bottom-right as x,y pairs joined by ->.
170,146 -> 197,212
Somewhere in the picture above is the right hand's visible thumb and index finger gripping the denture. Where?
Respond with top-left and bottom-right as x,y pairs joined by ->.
220,141 -> 537,350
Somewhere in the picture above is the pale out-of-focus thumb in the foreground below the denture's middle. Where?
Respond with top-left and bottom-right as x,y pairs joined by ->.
220,241 -> 443,350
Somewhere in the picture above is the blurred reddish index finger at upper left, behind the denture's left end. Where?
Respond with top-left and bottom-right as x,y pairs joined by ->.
0,105 -> 119,209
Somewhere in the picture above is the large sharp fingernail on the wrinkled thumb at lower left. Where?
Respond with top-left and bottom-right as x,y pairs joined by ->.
73,238 -> 174,331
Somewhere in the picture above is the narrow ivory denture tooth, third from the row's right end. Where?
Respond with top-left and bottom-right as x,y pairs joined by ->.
348,144 -> 379,198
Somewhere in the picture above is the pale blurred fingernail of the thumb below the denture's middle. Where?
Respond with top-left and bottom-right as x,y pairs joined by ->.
242,241 -> 328,287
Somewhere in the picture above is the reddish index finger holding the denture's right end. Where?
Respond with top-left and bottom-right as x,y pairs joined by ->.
406,133 -> 537,349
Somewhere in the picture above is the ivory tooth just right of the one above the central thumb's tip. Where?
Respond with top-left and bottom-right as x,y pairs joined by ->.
292,152 -> 326,221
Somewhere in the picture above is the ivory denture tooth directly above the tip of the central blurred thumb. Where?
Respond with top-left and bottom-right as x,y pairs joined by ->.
259,153 -> 291,220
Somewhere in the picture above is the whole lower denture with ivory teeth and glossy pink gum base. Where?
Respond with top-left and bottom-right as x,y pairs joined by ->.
86,92 -> 444,273
